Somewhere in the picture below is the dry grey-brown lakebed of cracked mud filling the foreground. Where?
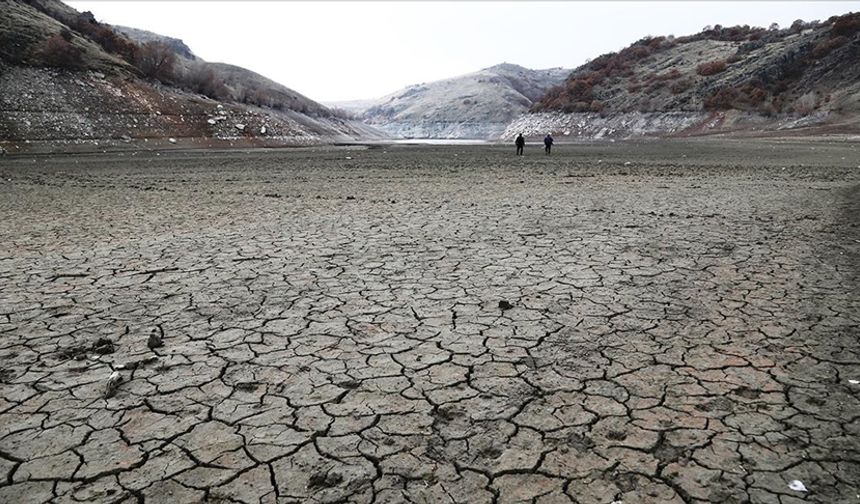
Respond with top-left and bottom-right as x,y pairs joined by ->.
0,141 -> 860,504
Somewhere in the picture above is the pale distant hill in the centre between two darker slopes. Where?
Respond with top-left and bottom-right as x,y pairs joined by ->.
356,63 -> 570,139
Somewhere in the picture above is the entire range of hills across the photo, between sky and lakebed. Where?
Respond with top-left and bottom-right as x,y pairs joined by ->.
0,0 -> 860,149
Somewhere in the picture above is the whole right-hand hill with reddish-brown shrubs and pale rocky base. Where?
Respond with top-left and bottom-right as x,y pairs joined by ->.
503,14 -> 860,138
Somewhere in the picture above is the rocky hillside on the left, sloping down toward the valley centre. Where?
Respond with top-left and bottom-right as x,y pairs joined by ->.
0,0 -> 383,151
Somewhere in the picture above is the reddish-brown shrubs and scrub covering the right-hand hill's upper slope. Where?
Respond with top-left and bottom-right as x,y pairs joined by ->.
532,13 -> 860,115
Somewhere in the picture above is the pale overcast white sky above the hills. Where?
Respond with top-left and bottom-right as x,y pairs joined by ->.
67,0 -> 860,102
